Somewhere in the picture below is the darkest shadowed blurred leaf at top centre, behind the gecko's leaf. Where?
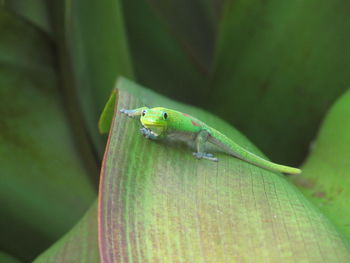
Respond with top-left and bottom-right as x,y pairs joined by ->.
123,0 -> 209,103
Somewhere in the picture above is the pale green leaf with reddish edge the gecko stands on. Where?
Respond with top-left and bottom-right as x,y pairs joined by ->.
98,79 -> 350,262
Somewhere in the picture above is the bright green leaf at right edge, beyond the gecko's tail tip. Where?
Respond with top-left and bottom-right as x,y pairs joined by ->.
293,91 -> 350,237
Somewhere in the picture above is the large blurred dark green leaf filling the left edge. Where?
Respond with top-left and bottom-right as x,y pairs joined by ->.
0,9 -> 96,262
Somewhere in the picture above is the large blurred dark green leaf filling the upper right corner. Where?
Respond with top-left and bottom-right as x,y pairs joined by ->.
208,0 -> 350,164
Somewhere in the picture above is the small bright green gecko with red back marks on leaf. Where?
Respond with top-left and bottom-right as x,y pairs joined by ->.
120,107 -> 301,174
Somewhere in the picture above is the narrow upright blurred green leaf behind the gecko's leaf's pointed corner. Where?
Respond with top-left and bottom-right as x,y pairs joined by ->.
50,0 -> 133,155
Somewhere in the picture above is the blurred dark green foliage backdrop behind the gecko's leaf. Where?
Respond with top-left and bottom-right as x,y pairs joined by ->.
0,0 -> 350,262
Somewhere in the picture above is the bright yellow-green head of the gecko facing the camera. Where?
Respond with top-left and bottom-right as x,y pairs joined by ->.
140,107 -> 168,136
